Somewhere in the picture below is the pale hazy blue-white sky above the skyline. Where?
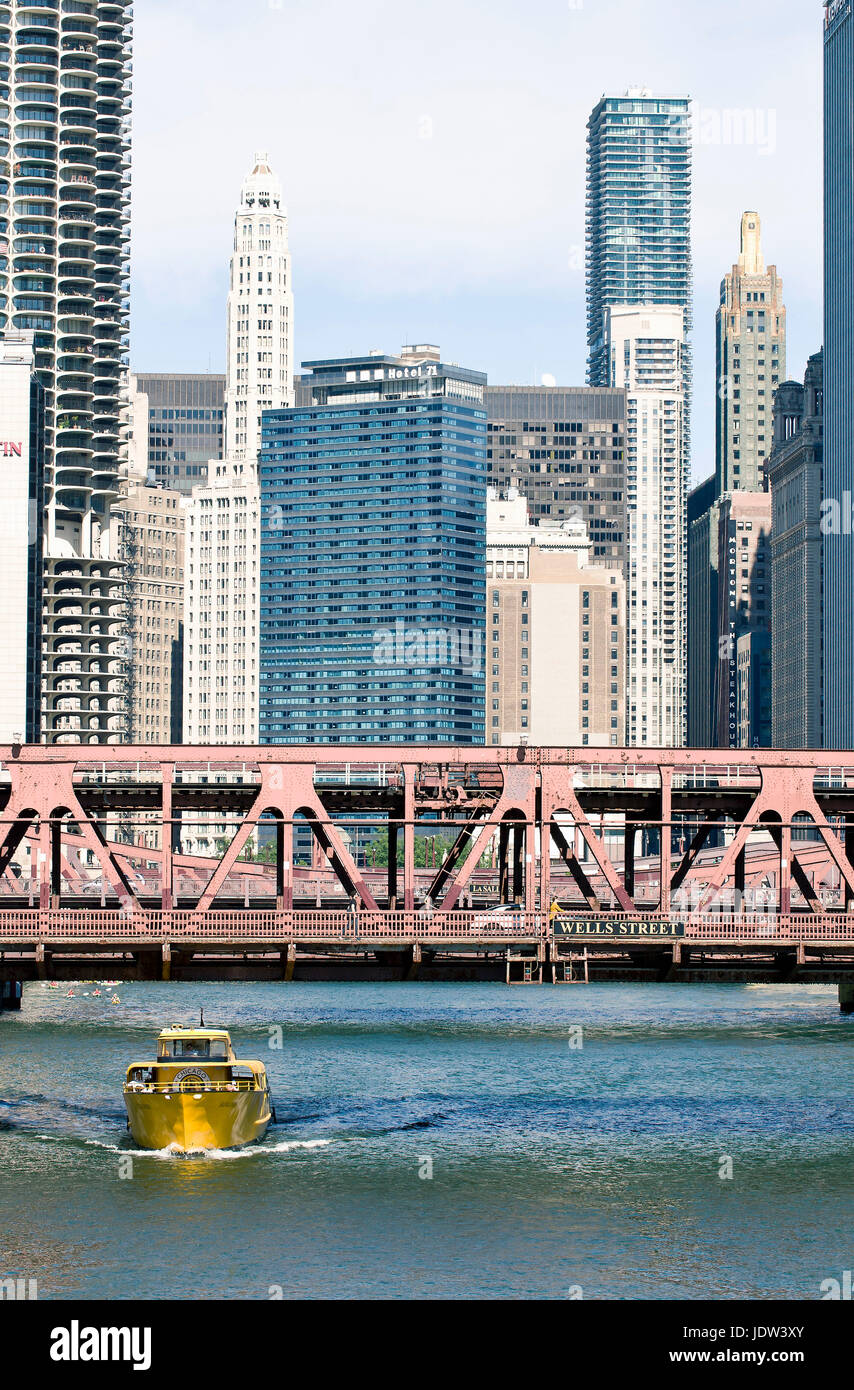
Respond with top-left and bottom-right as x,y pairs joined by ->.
131,0 -> 823,478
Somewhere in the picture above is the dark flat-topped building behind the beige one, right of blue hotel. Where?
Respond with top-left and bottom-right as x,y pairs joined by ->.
484,386 -> 626,566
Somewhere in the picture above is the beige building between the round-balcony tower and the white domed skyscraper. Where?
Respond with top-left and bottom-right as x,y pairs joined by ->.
115,484 -> 184,744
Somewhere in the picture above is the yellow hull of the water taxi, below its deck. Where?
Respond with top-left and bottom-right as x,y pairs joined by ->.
125,1090 -> 273,1154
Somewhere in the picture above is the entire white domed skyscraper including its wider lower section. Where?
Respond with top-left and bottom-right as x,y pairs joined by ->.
184,154 -> 293,750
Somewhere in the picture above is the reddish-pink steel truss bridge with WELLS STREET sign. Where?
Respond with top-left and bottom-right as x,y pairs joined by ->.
0,745 -> 854,981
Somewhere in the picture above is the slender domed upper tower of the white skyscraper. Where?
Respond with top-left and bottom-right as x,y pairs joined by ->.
225,153 -> 293,463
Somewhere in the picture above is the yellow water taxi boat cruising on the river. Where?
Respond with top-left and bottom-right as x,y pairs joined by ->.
124,1022 -> 274,1152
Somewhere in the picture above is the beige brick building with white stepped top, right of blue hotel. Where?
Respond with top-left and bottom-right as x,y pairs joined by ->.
487,488 -> 626,748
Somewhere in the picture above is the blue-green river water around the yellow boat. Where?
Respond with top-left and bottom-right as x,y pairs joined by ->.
0,983 -> 854,1300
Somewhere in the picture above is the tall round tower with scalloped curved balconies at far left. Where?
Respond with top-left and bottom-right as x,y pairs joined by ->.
0,0 -> 132,744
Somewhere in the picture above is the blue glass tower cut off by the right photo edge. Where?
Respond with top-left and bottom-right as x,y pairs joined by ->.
822,0 -> 854,748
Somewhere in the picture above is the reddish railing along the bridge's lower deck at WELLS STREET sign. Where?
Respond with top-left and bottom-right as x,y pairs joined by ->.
0,908 -> 854,949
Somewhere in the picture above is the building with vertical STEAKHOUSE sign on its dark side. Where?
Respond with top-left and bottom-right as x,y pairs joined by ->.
715,488 -> 771,748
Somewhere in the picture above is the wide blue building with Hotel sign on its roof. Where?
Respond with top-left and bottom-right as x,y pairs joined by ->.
260,346 -> 487,744
